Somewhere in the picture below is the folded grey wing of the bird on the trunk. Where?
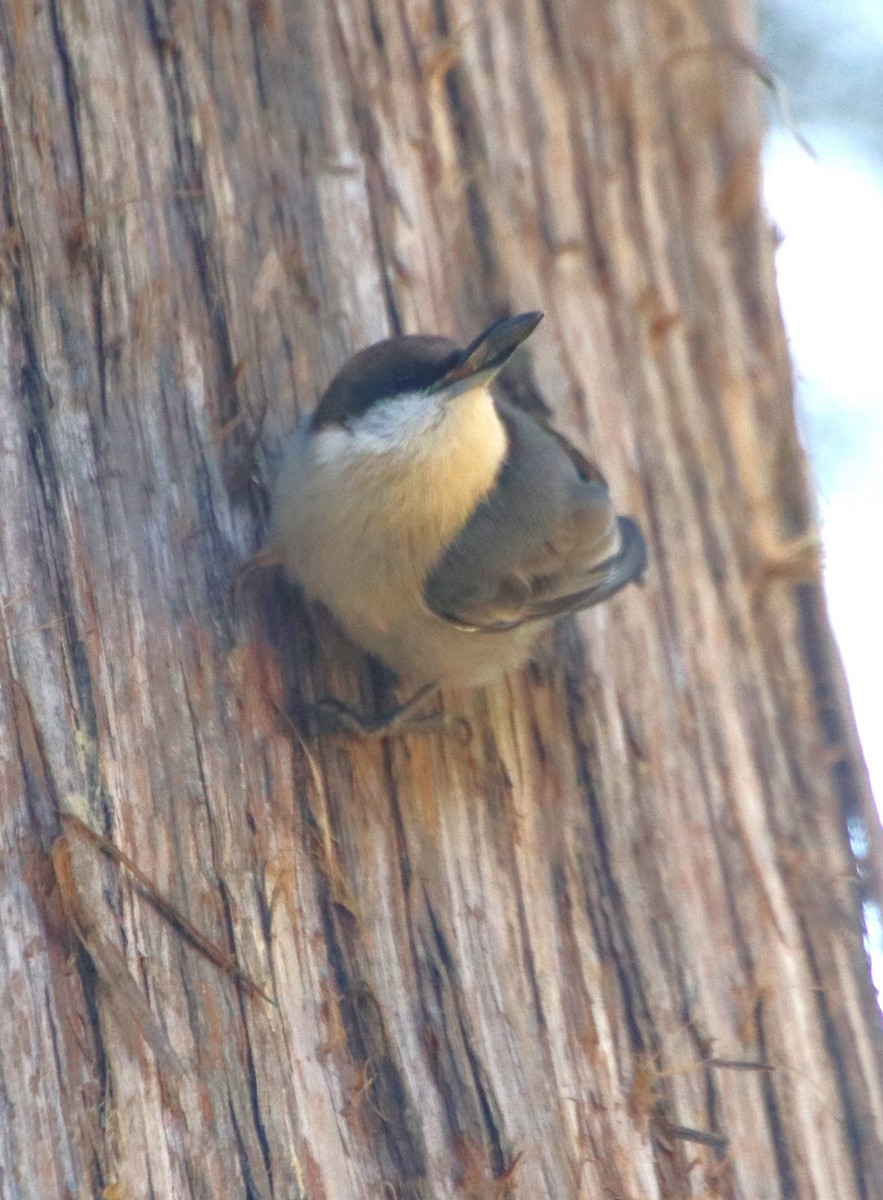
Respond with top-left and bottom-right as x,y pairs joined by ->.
425,402 -> 647,632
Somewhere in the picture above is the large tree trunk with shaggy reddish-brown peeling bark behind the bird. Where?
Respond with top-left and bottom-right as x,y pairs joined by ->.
0,0 -> 883,1200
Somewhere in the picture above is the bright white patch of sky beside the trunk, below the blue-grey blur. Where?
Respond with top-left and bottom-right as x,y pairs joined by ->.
765,131 -> 883,802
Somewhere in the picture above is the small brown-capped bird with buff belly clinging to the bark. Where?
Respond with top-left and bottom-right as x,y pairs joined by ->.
270,312 -> 647,736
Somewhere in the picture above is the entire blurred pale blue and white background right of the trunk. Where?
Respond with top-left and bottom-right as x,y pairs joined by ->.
759,0 -> 883,995
